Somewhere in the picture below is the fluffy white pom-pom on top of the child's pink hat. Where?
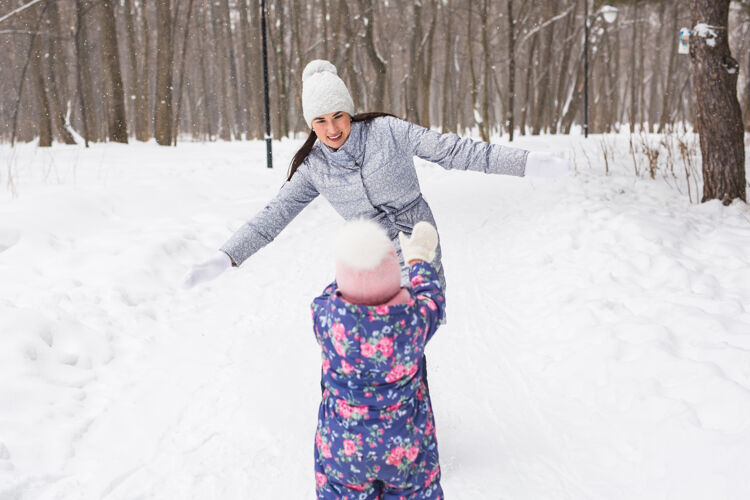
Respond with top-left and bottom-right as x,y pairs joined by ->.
334,219 -> 394,270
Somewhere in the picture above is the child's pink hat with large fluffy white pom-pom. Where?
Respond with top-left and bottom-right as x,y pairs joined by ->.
335,219 -> 401,306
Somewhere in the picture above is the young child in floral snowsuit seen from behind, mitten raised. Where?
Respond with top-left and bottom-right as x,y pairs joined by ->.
312,220 -> 445,500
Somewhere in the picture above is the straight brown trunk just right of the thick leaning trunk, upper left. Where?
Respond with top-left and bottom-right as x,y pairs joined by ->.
154,0 -> 172,146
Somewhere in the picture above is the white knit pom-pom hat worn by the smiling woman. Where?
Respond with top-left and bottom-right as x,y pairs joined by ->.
302,59 -> 354,127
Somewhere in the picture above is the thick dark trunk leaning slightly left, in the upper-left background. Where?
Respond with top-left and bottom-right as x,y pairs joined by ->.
100,0 -> 128,144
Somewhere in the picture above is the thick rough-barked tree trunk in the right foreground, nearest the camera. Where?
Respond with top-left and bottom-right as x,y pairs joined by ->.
690,0 -> 746,205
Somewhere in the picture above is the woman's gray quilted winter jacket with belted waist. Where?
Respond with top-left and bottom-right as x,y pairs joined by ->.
221,116 -> 528,286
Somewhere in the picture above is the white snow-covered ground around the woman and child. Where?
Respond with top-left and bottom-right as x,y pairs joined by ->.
0,136 -> 750,500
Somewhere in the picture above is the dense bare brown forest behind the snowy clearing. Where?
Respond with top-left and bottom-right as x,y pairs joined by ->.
0,0 -> 750,145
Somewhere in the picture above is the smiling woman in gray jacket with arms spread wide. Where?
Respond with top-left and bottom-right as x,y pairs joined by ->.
184,60 -> 570,288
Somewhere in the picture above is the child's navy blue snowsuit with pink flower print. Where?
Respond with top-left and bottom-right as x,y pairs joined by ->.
312,262 -> 445,500
